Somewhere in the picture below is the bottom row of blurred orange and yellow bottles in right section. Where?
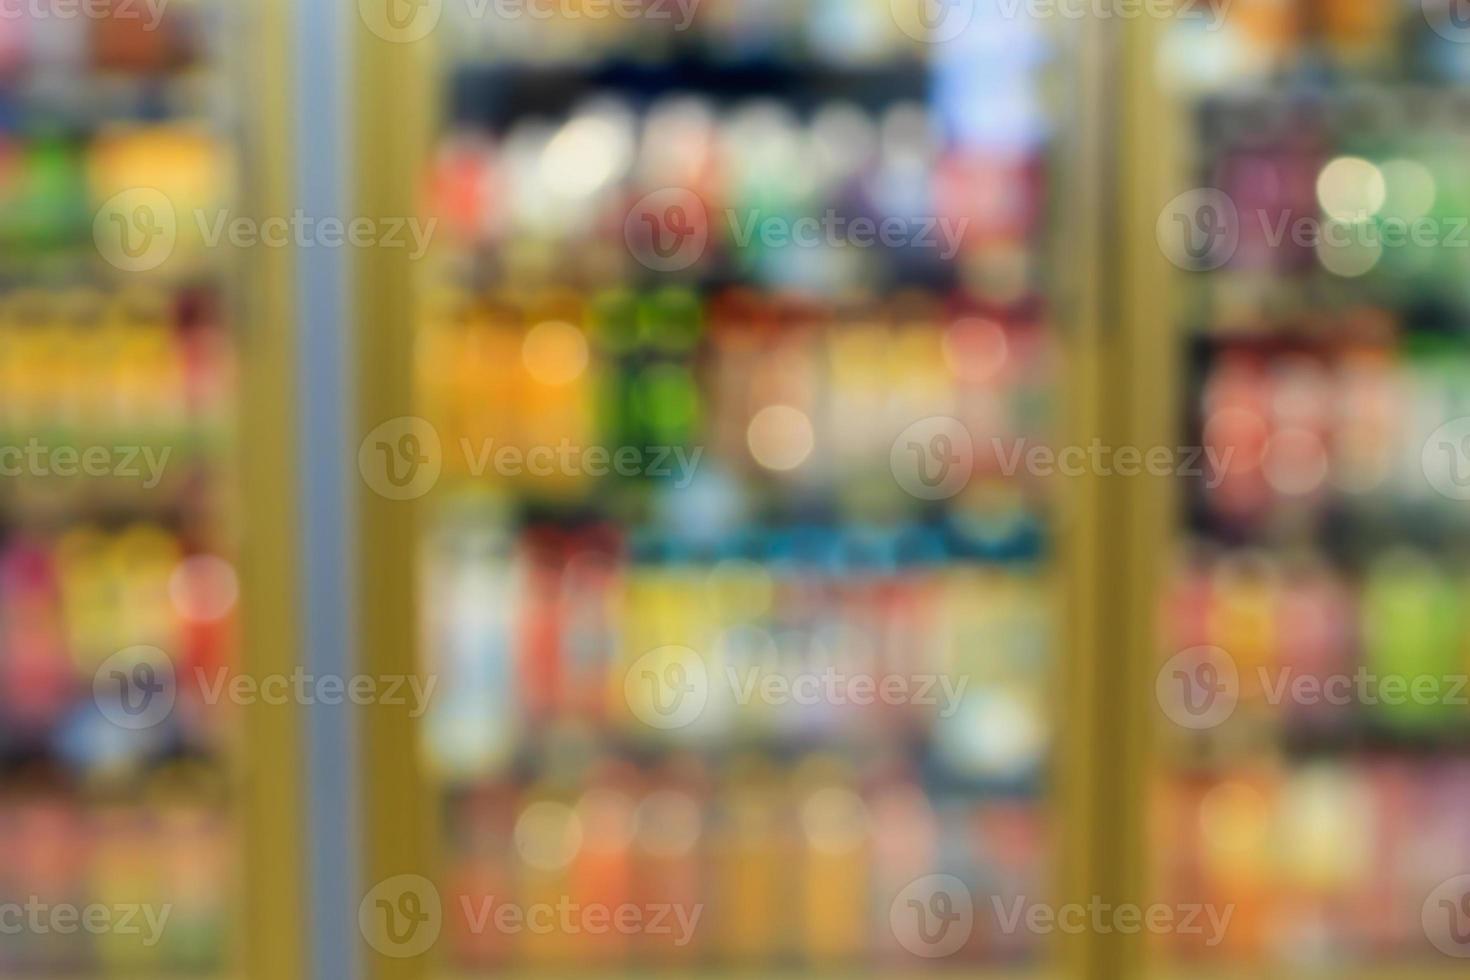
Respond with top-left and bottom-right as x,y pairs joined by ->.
1155,757 -> 1470,976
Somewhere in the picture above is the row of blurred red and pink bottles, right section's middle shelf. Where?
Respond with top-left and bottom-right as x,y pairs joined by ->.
1198,341 -> 1470,533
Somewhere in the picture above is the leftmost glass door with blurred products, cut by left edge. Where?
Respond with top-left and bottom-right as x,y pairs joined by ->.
0,0 -> 285,976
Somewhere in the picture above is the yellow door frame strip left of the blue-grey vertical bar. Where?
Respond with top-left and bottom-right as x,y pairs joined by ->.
234,0 -> 307,980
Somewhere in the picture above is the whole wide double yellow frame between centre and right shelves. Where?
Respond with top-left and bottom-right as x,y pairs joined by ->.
1053,16 -> 1180,980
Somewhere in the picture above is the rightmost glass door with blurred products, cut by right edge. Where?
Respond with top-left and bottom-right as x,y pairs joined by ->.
1152,0 -> 1470,977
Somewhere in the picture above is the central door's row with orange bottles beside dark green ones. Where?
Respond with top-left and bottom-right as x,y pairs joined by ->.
419,288 -> 1053,525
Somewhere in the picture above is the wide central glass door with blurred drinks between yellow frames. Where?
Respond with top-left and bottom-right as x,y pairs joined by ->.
359,0 -> 1093,974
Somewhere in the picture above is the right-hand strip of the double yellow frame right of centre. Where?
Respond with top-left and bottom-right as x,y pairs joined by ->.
1094,11 -> 1183,979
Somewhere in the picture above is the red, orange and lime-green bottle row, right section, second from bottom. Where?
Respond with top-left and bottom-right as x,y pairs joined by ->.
1160,548 -> 1470,739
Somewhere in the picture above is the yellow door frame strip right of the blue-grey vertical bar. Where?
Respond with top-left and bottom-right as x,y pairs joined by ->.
348,13 -> 437,980
